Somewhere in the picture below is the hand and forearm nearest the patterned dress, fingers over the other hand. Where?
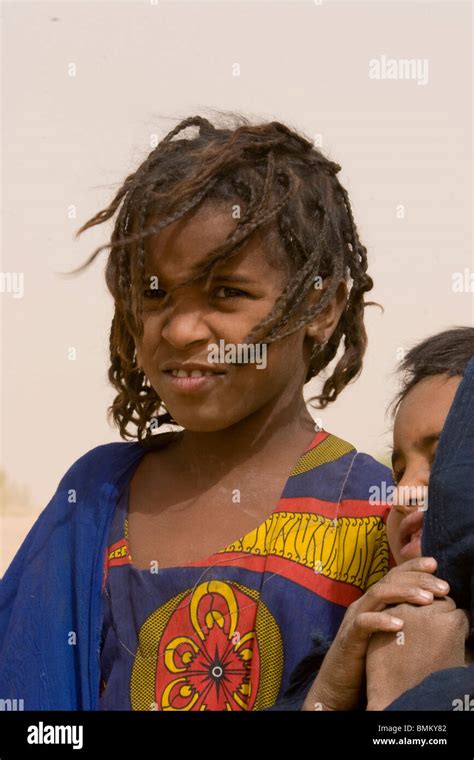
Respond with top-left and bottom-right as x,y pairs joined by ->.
301,557 -> 449,710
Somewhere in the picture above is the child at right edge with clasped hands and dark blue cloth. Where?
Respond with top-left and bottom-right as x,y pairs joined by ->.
276,327 -> 474,710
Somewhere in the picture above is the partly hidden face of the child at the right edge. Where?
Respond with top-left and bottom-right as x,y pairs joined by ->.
387,375 -> 462,565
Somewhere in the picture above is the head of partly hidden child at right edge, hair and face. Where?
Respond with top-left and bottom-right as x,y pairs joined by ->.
387,327 -> 474,564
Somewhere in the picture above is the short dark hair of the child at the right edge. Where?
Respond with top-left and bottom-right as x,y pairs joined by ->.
390,327 -> 474,417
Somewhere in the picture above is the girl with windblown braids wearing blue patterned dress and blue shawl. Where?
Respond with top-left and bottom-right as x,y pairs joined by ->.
0,116 -> 442,711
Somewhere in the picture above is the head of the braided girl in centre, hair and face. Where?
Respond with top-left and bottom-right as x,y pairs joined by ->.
77,110 -> 373,438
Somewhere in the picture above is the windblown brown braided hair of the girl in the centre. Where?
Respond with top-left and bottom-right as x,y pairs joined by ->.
74,112 -> 373,439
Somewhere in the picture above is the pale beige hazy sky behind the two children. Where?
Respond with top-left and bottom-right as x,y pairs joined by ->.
0,0 -> 474,574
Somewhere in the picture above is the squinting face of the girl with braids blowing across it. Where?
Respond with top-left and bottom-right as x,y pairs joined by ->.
133,206 -> 346,432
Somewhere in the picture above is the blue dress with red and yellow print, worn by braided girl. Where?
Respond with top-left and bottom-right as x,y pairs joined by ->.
99,431 -> 389,711
